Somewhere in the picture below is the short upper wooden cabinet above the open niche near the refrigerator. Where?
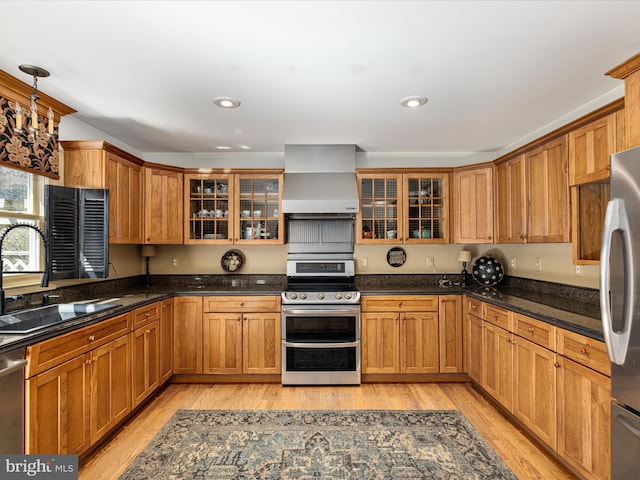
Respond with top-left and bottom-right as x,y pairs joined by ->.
568,110 -> 625,185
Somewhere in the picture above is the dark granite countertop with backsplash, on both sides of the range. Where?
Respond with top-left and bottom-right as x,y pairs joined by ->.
0,275 -> 603,352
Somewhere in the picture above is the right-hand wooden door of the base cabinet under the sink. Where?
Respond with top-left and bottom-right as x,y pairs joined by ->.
90,335 -> 131,444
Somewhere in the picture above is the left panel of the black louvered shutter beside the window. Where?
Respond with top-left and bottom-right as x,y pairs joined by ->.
44,185 -> 78,280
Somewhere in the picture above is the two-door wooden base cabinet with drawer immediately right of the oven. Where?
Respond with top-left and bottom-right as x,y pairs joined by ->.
361,295 -> 439,374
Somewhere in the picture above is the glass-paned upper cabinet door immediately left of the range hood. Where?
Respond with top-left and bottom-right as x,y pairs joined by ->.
236,175 -> 283,243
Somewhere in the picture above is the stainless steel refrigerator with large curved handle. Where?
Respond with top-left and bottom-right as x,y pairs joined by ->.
600,147 -> 640,480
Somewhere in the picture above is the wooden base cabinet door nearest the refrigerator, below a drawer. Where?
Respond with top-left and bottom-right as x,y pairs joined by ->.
556,355 -> 611,479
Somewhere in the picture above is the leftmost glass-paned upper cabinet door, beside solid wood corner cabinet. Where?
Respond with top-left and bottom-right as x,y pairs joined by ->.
185,176 -> 233,243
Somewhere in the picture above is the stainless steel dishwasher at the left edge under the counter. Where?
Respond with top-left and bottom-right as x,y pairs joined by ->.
0,349 -> 27,454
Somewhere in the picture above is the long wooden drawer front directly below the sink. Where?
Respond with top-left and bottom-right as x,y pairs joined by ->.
26,312 -> 131,378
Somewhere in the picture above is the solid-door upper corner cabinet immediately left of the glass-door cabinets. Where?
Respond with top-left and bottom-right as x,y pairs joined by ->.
143,164 -> 184,244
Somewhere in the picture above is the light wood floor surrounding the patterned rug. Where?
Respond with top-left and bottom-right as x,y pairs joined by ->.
80,383 -> 575,480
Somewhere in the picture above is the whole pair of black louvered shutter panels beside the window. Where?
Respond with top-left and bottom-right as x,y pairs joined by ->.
44,185 -> 109,280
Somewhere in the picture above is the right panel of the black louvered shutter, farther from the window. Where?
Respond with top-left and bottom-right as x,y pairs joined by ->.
79,189 -> 109,278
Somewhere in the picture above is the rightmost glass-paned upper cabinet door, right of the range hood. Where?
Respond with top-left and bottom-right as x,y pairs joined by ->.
405,174 -> 449,243
